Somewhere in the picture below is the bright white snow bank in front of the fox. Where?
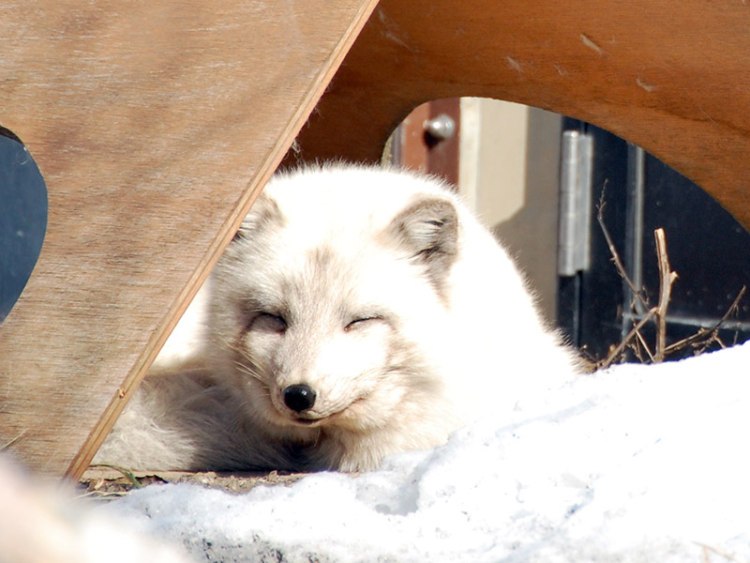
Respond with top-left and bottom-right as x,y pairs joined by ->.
86,344 -> 750,562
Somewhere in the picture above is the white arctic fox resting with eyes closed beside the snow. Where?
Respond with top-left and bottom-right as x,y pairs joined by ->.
97,165 -> 579,471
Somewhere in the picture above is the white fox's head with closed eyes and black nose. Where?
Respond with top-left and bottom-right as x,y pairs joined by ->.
210,166 -> 460,436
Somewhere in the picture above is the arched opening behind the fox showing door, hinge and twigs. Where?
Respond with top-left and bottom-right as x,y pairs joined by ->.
383,98 -> 750,363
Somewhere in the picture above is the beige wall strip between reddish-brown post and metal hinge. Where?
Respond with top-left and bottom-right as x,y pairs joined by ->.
459,98 -> 562,321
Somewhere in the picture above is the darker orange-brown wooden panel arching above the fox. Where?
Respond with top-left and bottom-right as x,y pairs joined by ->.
287,0 -> 750,231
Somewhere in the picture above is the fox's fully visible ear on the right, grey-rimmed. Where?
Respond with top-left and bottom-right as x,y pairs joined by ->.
389,198 -> 458,290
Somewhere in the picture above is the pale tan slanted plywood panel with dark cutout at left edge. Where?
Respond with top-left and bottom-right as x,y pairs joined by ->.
0,0 -> 375,476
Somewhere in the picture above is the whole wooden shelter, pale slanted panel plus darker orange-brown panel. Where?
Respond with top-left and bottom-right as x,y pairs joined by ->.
0,0 -> 750,477
